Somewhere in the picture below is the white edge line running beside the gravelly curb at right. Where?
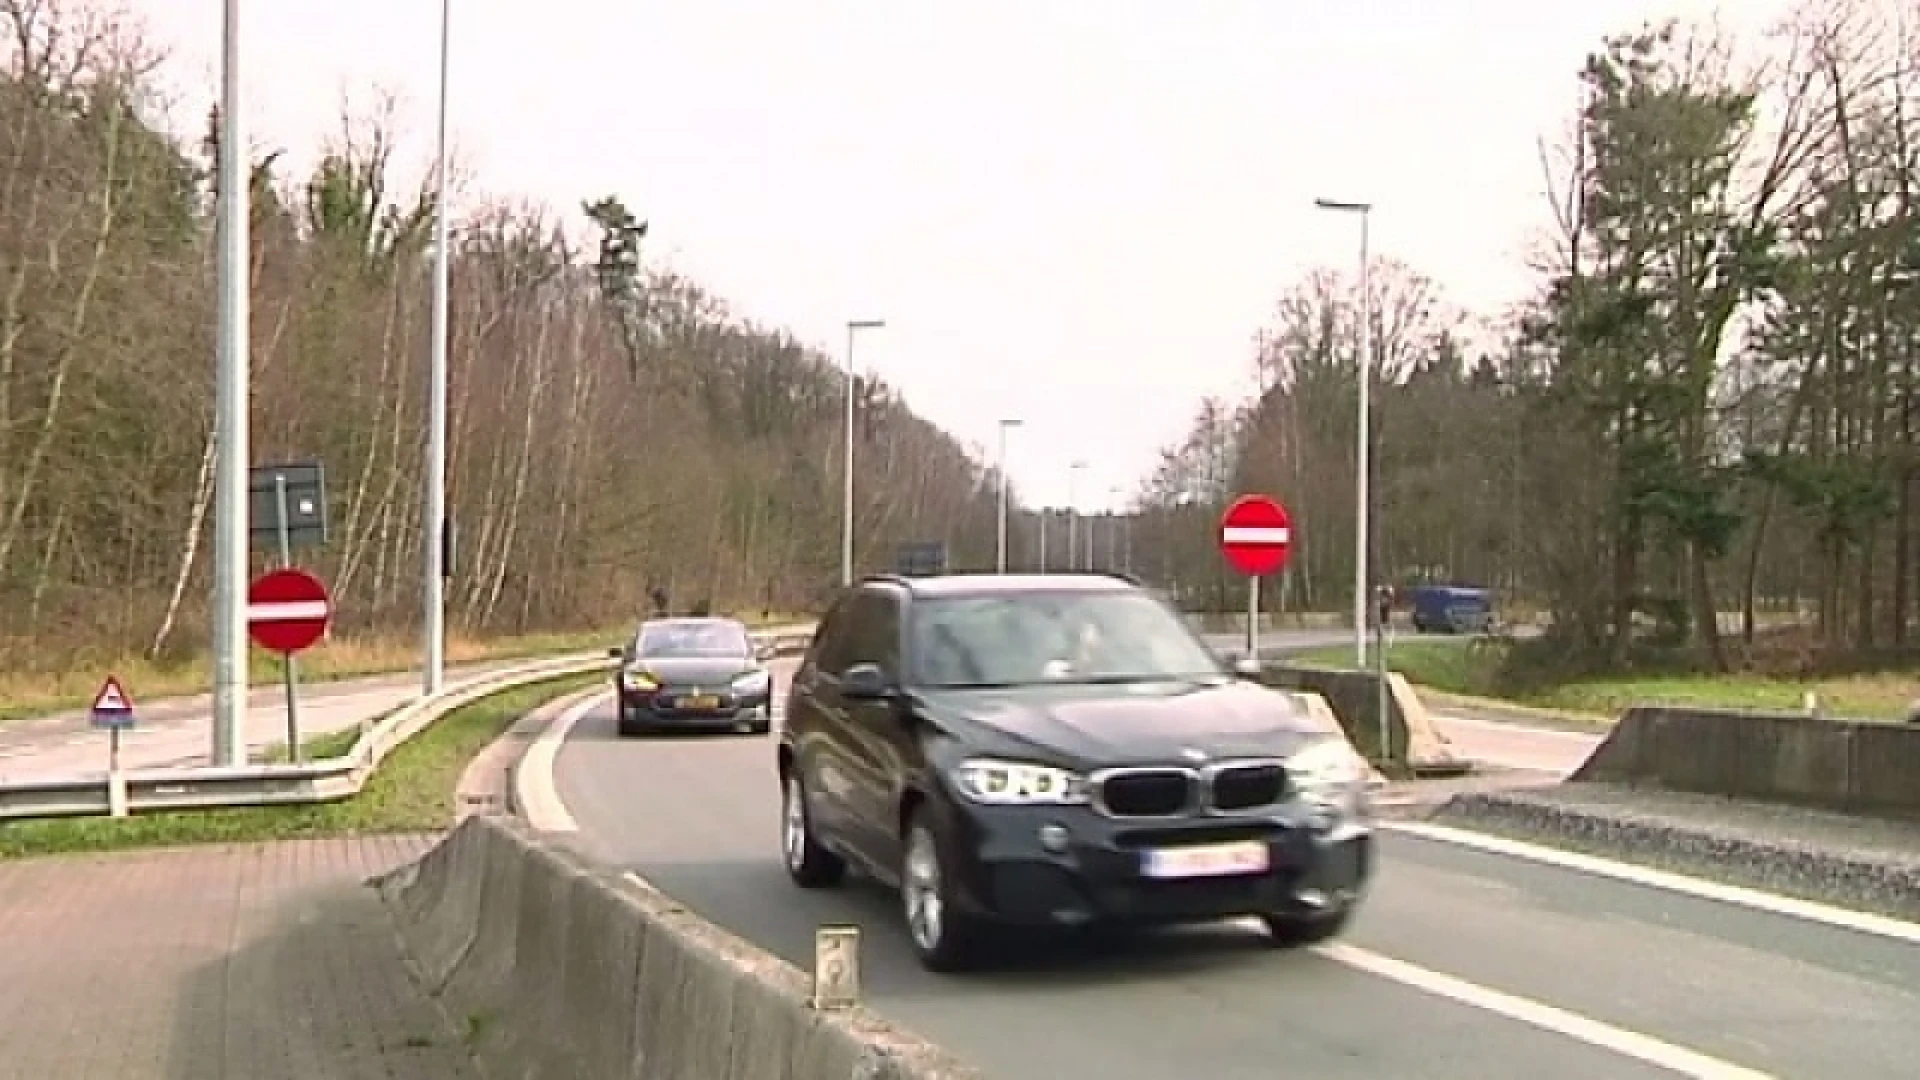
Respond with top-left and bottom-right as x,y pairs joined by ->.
1377,821 -> 1920,945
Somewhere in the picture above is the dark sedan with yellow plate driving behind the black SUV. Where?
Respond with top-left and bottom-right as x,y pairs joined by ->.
611,617 -> 774,736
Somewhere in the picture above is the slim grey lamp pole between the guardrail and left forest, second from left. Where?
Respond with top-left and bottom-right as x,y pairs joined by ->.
420,0 -> 453,694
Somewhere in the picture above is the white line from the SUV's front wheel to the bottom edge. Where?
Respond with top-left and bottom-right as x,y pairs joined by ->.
1313,944 -> 1772,1080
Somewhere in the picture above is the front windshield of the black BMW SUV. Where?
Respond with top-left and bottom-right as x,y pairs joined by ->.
908,590 -> 1221,690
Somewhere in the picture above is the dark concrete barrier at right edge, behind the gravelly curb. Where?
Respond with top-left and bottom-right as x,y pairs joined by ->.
1571,705 -> 1920,813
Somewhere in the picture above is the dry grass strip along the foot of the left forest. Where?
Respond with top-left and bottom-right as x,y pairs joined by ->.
0,613 -> 806,726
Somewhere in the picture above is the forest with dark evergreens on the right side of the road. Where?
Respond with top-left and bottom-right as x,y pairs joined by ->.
1133,0 -> 1920,671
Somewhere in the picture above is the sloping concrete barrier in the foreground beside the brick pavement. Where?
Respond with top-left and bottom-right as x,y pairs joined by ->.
376,815 -> 979,1080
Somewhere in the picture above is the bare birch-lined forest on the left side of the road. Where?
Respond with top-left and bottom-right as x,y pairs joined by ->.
0,0 -> 995,675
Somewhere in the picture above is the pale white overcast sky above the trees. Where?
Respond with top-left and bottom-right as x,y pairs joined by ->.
132,0 -> 1784,509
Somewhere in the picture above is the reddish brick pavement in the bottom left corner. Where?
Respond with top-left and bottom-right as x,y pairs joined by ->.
0,836 -> 478,1080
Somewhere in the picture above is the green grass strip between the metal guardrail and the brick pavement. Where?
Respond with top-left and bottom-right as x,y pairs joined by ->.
0,673 -> 605,859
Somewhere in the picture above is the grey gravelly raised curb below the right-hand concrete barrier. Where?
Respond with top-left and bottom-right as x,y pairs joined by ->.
1427,780 -> 1920,920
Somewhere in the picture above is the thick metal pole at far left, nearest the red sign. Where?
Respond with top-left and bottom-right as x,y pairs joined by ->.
213,0 -> 252,765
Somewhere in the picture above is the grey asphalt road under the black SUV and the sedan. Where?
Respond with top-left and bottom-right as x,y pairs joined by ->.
555,665 -> 1920,1080
